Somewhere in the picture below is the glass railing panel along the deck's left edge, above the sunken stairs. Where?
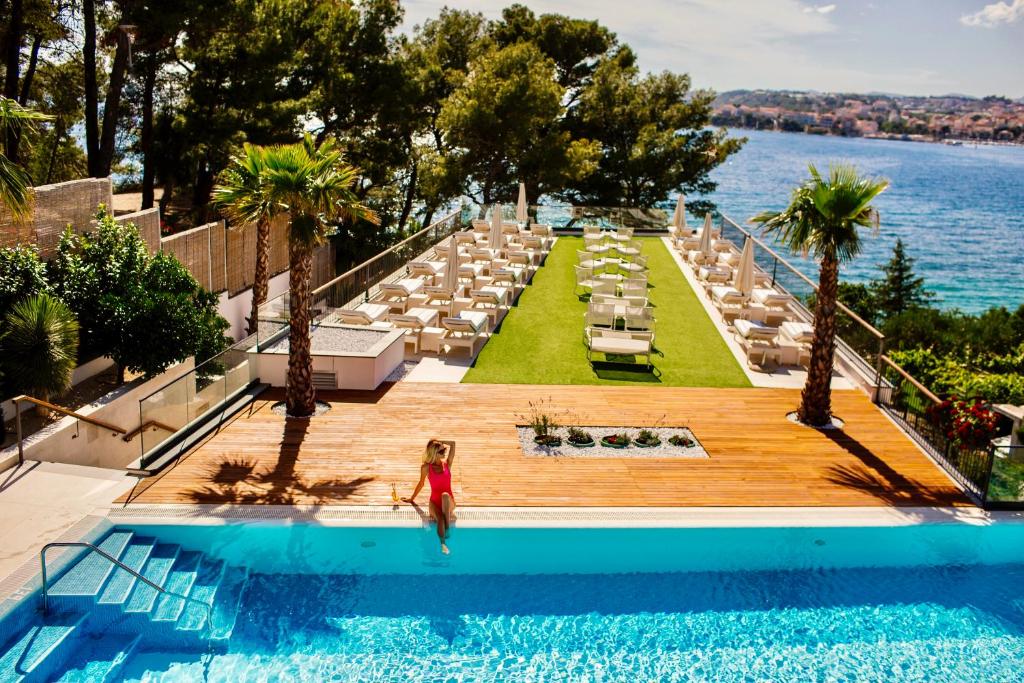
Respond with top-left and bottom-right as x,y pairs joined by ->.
138,336 -> 256,467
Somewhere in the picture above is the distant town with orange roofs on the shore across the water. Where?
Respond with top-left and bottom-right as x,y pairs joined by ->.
712,90 -> 1024,144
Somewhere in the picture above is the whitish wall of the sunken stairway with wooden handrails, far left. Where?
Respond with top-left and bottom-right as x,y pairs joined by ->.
0,358 -> 196,471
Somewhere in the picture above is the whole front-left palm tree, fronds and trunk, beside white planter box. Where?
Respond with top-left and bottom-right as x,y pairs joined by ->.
263,135 -> 378,417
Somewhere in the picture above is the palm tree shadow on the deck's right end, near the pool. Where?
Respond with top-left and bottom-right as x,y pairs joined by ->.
819,429 -> 969,516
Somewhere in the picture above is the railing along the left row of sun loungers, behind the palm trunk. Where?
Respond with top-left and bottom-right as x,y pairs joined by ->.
256,207 -> 467,348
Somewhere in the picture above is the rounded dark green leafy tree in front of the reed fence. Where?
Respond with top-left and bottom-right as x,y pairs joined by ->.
50,209 -> 227,382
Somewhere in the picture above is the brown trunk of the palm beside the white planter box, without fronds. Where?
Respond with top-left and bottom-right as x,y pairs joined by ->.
286,239 -> 316,418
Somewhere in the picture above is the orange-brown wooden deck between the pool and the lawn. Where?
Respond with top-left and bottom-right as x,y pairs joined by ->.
119,382 -> 969,506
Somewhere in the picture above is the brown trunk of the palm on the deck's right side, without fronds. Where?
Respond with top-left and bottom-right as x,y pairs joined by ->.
798,254 -> 839,426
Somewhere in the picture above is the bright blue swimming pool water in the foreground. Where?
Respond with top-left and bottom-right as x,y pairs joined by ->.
6,523 -> 1024,681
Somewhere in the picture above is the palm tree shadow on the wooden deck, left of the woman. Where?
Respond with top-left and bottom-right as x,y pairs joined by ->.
186,419 -> 374,506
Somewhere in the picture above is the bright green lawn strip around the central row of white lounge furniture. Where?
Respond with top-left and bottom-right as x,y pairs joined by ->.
463,238 -> 751,387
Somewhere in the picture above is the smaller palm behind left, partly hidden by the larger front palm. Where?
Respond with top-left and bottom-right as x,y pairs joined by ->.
213,142 -> 280,335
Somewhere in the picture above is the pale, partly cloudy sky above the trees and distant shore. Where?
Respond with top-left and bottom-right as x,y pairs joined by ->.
403,0 -> 1024,98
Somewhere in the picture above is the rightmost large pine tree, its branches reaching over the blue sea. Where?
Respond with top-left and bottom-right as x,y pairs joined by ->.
562,48 -> 744,213
